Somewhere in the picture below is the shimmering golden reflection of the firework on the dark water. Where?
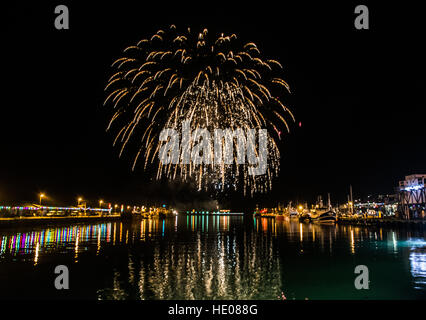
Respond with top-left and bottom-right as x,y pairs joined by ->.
125,230 -> 281,299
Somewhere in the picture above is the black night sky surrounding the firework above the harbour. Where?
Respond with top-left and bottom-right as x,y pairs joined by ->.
0,1 -> 426,208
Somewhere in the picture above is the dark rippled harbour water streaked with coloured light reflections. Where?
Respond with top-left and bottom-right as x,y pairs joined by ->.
0,215 -> 426,299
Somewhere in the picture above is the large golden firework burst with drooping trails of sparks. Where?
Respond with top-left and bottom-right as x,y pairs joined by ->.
104,25 -> 294,193
